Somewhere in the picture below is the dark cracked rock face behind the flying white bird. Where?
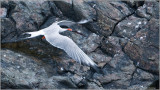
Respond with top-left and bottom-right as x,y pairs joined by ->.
0,0 -> 159,89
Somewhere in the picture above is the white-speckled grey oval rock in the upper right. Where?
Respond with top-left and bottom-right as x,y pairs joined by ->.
114,16 -> 148,39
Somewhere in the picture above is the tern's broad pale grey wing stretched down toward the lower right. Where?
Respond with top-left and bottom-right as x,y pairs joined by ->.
46,34 -> 97,69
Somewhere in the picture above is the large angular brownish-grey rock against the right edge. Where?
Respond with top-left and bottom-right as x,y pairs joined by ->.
124,18 -> 159,74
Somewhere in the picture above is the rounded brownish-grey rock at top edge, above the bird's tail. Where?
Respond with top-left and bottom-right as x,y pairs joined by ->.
11,1 -> 51,32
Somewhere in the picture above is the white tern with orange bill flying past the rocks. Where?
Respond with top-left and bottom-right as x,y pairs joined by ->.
24,20 -> 100,72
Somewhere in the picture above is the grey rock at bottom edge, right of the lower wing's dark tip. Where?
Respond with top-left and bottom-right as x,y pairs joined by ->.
93,52 -> 135,89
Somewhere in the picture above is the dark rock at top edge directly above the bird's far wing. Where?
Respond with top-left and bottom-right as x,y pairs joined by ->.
54,0 -> 95,20
